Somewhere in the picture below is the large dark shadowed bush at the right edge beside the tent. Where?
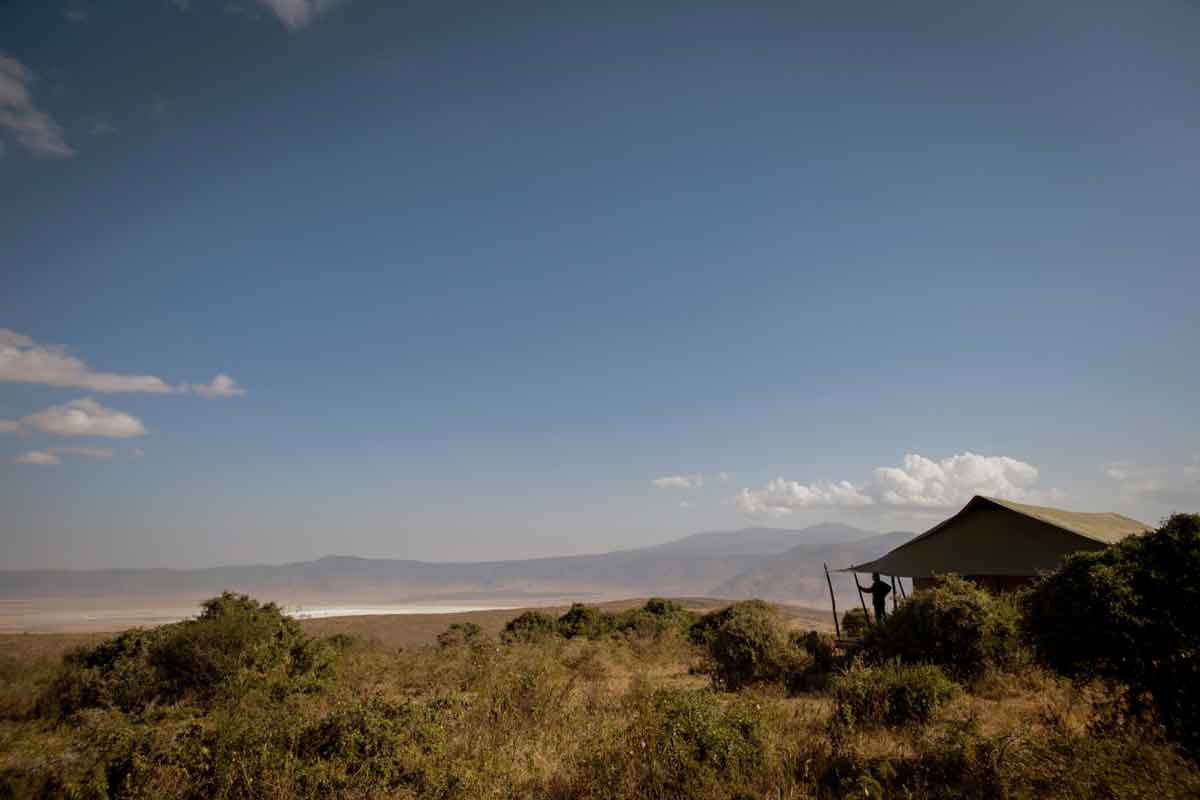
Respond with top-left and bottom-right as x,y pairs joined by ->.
1022,513 -> 1200,756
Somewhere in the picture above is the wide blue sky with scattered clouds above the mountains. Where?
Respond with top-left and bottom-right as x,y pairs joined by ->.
0,0 -> 1200,567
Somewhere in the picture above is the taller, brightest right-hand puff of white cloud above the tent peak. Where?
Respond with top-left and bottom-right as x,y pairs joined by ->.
871,452 -> 1038,509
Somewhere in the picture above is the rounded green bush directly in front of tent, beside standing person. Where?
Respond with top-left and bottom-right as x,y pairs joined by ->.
863,575 -> 1020,680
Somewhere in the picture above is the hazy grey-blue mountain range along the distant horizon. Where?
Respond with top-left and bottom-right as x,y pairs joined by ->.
0,523 -> 912,604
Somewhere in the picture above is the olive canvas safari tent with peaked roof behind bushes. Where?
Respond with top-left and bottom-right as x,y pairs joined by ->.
847,495 -> 1151,591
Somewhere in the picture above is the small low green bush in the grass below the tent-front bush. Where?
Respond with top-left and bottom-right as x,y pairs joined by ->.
830,662 -> 960,728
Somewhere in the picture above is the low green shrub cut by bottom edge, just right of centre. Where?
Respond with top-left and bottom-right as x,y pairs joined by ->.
570,688 -> 767,800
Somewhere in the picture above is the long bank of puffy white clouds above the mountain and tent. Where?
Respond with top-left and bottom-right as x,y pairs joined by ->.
734,452 -> 1048,519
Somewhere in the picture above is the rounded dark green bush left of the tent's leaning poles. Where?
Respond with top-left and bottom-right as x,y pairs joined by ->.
691,600 -> 803,691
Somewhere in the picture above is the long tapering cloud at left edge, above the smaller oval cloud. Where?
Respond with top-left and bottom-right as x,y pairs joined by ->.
0,329 -> 246,399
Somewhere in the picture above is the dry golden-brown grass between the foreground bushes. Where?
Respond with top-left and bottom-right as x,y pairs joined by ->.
0,600 -> 1200,800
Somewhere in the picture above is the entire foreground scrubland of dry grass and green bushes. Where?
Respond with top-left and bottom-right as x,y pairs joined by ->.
0,516 -> 1200,800
